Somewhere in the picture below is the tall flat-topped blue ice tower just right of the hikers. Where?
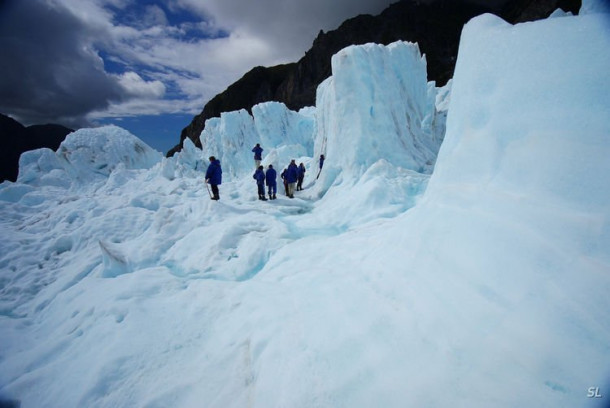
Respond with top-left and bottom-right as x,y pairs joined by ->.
315,41 -> 444,185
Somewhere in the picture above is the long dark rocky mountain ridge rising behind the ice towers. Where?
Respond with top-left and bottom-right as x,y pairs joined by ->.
168,0 -> 581,156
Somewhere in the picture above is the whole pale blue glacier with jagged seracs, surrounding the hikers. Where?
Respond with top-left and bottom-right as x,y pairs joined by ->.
0,1 -> 610,408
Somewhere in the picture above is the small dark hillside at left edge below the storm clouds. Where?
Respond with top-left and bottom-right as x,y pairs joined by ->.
0,114 -> 73,182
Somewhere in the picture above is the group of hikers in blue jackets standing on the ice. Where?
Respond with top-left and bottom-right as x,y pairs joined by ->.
205,143 -> 324,201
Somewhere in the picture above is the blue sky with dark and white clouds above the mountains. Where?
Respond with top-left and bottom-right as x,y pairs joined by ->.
0,0 -> 395,152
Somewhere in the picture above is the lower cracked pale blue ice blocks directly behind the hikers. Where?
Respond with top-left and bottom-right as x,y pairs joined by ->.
200,102 -> 314,180
